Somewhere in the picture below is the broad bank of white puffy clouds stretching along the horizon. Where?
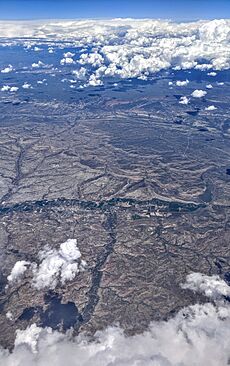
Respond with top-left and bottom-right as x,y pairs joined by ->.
0,19 -> 230,84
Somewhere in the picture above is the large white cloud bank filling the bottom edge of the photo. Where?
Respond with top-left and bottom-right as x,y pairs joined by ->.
0,273 -> 230,366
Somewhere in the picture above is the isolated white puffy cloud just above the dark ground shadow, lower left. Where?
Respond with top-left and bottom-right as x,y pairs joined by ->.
7,239 -> 86,289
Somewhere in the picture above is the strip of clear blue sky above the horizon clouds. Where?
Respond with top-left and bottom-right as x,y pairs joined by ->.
0,0 -> 230,20
